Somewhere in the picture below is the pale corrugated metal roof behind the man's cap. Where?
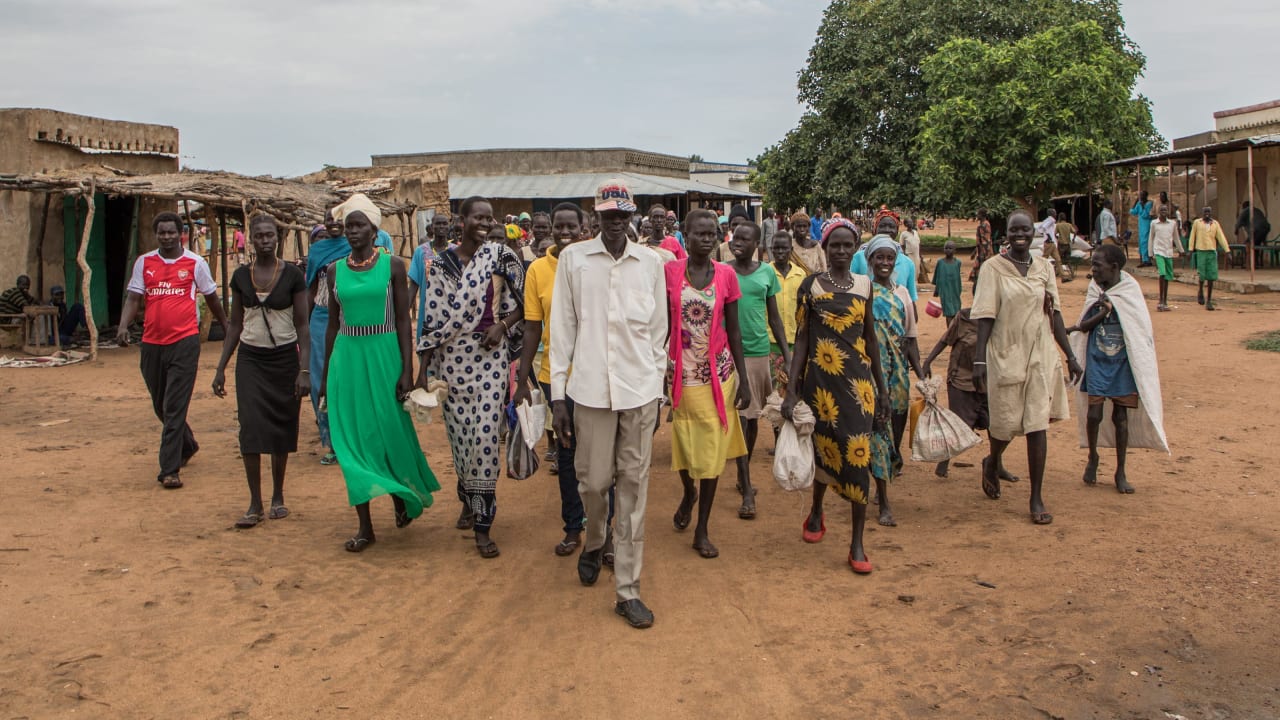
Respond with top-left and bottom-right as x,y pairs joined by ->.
449,173 -> 759,200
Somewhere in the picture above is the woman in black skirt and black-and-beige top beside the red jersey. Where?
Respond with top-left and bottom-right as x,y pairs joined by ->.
214,214 -> 311,528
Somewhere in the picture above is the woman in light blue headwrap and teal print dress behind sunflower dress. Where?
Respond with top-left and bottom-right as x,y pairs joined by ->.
867,234 -> 920,527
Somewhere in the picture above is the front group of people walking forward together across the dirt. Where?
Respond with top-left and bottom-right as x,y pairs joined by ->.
120,181 -> 1162,628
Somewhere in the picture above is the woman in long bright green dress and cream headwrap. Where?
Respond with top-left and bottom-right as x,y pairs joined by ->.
320,193 -> 440,552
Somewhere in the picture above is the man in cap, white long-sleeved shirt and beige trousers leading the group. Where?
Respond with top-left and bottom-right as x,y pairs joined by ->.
550,179 -> 667,628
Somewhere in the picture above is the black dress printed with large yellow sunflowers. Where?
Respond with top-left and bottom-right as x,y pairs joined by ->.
796,275 -> 876,505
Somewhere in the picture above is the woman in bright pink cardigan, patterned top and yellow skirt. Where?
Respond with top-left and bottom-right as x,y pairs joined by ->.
666,210 -> 748,559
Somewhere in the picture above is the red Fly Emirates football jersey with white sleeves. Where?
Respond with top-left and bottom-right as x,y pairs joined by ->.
129,250 -> 218,345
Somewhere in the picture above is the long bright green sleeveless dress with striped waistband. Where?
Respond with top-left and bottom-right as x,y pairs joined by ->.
326,254 -> 440,518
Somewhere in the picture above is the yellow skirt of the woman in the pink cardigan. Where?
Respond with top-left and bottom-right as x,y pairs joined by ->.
671,373 -> 746,480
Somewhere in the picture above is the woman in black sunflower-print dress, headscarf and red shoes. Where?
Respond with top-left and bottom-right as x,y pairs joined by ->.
782,219 -> 888,574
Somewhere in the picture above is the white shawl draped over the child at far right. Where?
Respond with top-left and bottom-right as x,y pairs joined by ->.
1071,270 -> 1169,452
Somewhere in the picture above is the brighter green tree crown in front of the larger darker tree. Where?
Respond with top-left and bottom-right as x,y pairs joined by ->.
918,20 -> 1158,206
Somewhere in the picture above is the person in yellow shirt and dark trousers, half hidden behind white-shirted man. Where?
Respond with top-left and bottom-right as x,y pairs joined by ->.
512,202 -> 588,557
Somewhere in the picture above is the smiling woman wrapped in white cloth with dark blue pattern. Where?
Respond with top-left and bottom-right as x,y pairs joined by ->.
417,197 -> 525,557
